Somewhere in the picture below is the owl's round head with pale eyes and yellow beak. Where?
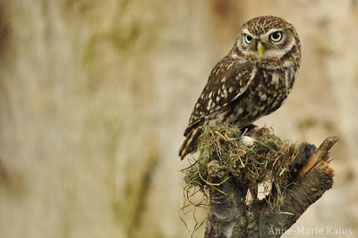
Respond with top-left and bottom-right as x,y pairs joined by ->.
236,16 -> 300,61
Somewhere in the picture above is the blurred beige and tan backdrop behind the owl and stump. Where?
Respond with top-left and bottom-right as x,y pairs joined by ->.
0,0 -> 358,238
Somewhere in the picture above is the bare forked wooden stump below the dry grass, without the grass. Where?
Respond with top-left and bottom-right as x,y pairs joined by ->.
201,130 -> 338,238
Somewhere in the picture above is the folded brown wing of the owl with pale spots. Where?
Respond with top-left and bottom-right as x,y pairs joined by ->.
184,56 -> 257,136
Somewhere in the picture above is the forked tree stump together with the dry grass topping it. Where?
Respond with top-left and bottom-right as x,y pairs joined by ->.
185,126 -> 338,238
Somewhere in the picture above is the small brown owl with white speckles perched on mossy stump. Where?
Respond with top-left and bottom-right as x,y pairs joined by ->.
179,16 -> 301,159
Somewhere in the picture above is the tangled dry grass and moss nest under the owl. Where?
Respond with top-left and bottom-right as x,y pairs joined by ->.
183,125 -> 299,206
